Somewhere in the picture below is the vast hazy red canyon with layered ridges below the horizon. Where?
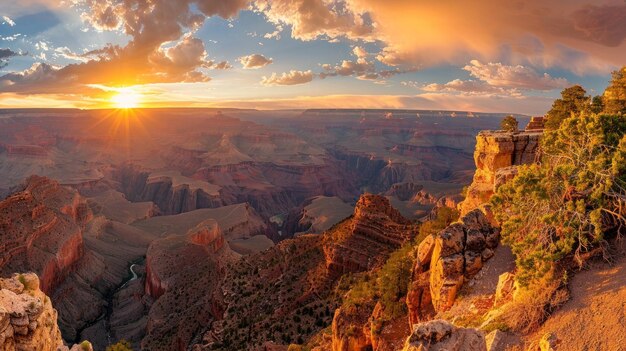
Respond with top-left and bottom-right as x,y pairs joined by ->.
0,109 -> 532,350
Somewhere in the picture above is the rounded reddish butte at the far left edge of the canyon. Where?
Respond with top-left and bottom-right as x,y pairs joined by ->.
0,176 -> 93,294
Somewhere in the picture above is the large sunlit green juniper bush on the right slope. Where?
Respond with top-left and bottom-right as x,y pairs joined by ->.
492,75 -> 626,286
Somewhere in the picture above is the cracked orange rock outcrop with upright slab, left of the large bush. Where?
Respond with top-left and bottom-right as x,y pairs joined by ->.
406,207 -> 500,325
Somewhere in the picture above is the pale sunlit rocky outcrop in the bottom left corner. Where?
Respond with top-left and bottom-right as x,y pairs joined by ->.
0,273 -> 93,351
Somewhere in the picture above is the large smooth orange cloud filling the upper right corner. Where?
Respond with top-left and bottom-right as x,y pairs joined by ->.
346,0 -> 626,73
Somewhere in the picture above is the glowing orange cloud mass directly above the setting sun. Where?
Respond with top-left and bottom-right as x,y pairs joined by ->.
0,0 -> 248,93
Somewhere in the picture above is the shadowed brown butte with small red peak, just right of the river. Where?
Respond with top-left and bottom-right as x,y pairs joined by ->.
141,219 -> 233,351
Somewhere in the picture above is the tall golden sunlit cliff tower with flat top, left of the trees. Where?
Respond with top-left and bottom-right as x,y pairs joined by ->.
461,130 -> 543,215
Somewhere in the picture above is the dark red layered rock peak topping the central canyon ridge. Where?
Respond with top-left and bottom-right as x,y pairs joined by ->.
324,194 -> 417,274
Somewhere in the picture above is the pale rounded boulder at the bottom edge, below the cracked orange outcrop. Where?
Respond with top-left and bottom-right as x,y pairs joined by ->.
402,320 -> 487,351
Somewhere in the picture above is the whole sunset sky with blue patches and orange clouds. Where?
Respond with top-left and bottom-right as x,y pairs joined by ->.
0,0 -> 626,115
